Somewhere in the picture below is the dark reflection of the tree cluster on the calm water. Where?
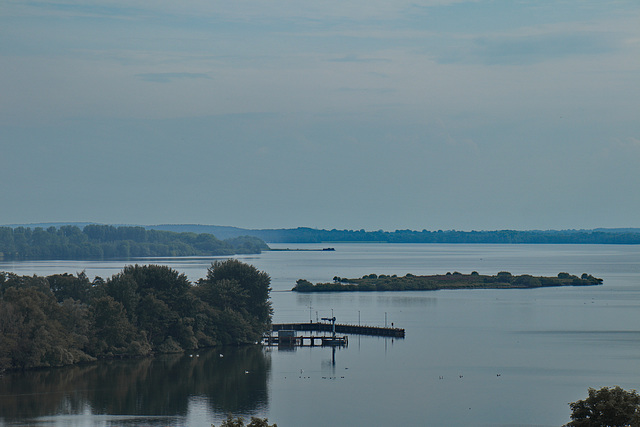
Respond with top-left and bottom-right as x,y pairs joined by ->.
0,346 -> 271,422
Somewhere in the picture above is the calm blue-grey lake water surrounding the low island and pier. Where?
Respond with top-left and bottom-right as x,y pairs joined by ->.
0,244 -> 640,427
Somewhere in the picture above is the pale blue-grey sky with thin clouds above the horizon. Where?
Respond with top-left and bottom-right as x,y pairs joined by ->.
0,0 -> 640,231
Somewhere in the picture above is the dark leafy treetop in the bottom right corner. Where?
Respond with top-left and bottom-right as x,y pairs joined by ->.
565,386 -> 640,427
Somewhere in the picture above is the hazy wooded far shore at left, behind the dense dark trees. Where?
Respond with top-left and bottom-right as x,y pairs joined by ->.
0,224 -> 269,260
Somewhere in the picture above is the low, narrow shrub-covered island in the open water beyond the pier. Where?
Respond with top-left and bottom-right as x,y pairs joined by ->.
292,271 -> 602,292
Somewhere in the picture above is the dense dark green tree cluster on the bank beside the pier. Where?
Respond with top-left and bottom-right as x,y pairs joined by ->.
0,259 -> 272,371
